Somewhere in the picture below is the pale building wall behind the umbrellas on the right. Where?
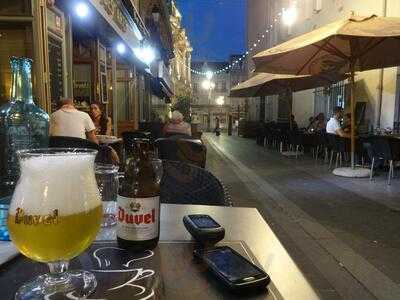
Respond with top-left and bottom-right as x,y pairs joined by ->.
247,0 -> 400,128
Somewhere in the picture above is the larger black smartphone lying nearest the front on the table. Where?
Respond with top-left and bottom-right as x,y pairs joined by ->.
194,246 -> 271,291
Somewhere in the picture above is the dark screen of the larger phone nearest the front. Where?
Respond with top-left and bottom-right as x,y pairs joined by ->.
204,248 -> 264,282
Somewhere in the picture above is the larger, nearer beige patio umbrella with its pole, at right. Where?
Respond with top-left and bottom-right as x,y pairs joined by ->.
253,15 -> 400,173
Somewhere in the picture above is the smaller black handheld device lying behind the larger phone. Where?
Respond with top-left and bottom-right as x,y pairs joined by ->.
183,215 -> 225,245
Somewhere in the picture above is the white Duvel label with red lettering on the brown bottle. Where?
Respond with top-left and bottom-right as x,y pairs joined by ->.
117,195 -> 160,241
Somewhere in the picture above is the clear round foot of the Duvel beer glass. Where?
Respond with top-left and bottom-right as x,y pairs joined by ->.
15,270 -> 97,300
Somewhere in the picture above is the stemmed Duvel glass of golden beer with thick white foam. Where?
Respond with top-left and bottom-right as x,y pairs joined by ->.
8,148 -> 103,299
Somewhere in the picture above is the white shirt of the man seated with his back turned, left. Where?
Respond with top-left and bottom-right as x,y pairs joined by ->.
50,108 -> 96,139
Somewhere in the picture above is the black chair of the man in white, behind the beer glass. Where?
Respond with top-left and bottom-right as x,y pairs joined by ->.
49,136 -> 113,164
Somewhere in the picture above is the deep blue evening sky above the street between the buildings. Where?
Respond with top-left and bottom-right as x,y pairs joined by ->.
176,0 -> 247,61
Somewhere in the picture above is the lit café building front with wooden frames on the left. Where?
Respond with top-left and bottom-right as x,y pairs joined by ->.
0,0 -> 173,134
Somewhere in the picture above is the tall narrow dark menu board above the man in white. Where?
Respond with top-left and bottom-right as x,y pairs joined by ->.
49,36 -> 64,111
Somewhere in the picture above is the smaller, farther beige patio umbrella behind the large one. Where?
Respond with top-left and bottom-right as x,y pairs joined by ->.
230,73 -> 346,128
